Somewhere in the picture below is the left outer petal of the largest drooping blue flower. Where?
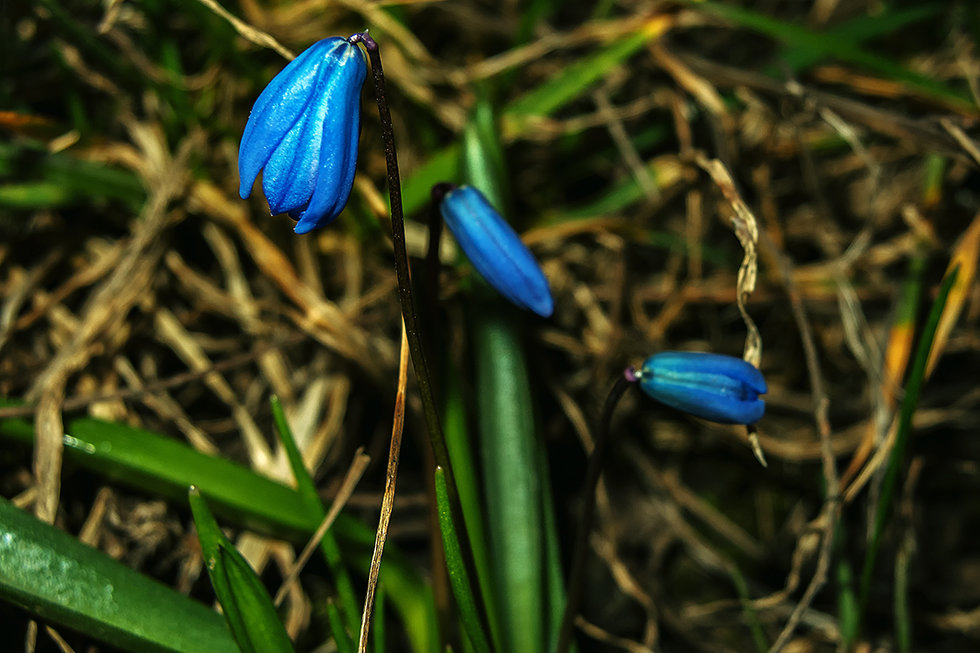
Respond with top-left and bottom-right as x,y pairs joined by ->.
238,37 -> 344,199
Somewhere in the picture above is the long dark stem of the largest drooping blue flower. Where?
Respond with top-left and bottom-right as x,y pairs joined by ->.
347,32 -> 482,648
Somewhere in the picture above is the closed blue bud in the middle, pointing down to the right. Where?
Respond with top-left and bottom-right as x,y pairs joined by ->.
440,186 -> 554,317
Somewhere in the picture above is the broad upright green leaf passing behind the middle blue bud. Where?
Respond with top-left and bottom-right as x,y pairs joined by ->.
463,96 -> 564,652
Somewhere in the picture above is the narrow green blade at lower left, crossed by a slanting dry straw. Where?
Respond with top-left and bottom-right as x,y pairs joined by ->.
270,396 -> 360,648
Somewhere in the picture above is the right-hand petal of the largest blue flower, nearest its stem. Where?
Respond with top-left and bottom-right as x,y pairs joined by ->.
294,41 -> 367,234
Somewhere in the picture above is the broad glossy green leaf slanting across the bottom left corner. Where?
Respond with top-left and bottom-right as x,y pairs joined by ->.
0,498 -> 238,653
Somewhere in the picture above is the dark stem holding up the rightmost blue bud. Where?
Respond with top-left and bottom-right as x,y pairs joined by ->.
555,368 -> 636,653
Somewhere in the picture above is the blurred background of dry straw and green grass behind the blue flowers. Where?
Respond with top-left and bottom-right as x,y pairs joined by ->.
0,0 -> 980,652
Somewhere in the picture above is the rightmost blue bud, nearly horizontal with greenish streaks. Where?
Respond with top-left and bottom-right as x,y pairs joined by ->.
634,351 -> 768,424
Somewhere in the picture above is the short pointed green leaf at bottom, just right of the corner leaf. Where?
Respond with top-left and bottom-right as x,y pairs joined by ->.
187,487 -> 293,653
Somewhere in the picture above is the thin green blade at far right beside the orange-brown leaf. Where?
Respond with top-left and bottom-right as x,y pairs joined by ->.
860,268 -> 957,615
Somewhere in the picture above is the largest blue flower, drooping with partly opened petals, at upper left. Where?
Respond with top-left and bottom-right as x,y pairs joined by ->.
238,37 -> 367,234
